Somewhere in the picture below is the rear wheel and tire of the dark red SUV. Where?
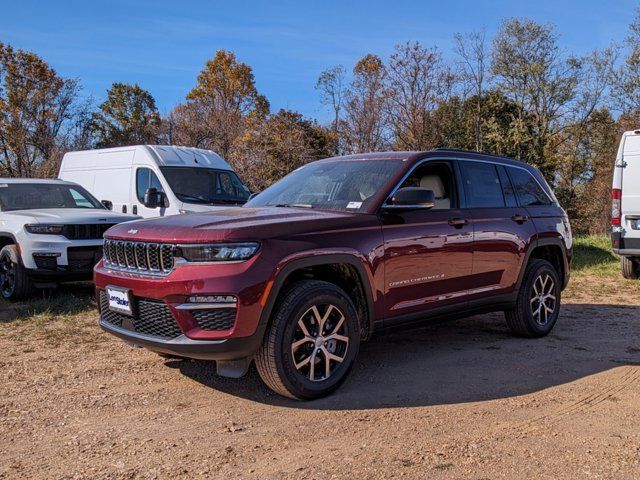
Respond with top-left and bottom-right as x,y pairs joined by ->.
504,259 -> 562,338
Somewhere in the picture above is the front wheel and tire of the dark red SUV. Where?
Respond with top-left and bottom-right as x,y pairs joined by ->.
255,280 -> 360,400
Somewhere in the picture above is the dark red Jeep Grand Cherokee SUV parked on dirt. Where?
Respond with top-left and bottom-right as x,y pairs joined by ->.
95,149 -> 572,399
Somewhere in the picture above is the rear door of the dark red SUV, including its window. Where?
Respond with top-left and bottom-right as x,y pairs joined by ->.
459,160 -> 536,301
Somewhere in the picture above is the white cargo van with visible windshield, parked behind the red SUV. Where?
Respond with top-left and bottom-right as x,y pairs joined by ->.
58,145 -> 251,217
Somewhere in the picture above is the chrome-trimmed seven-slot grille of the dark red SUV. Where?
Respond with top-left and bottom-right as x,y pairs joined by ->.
104,238 -> 173,275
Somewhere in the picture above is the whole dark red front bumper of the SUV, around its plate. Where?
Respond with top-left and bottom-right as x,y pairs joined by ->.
94,253 -> 273,360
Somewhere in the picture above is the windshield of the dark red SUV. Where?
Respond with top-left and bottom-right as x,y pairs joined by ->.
246,160 -> 402,212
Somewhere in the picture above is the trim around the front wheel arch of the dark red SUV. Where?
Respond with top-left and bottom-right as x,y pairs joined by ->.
260,253 -> 375,338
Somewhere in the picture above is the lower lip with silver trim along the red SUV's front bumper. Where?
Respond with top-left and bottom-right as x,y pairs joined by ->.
100,318 -> 264,361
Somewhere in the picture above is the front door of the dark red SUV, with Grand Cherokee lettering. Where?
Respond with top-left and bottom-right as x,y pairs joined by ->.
381,160 -> 473,318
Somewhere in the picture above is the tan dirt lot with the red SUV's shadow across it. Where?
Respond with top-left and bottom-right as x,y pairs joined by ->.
0,238 -> 640,479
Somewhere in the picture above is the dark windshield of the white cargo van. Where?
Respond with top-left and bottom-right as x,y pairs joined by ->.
160,167 -> 251,205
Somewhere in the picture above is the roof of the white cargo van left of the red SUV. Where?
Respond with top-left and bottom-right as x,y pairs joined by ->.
60,145 -> 232,170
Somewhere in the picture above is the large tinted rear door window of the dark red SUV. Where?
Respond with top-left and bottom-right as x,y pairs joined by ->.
460,161 -> 505,208
